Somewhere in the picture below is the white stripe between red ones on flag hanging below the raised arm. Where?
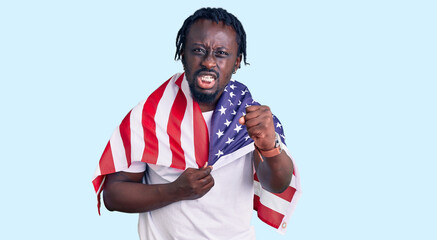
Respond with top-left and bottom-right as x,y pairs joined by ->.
253,181 -> 290,215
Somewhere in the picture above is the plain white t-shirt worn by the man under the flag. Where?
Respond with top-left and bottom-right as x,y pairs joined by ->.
126,111 -> 255,240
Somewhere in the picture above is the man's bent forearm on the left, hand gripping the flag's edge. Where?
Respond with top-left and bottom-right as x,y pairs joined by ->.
103,167 -> 214,213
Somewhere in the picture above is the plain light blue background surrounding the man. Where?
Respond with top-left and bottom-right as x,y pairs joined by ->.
0,0 -> 437,239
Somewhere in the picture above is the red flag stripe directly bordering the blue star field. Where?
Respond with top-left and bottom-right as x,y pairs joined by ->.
193,101 -> 209,167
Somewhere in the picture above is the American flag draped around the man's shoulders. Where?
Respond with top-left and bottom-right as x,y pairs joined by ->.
93,74 -> 301,233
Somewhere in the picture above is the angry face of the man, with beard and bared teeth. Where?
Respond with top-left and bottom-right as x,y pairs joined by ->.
182,19 -> 241,110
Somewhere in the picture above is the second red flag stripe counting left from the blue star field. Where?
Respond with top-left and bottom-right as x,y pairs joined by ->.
167,89 -> 187,169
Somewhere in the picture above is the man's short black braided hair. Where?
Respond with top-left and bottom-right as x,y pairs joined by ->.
175,7 -> 248,65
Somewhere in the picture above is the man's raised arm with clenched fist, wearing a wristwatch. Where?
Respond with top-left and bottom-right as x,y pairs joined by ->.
240,106 -> 293,193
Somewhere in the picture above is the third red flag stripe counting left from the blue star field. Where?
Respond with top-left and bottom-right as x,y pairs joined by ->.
141,78 -> 171,164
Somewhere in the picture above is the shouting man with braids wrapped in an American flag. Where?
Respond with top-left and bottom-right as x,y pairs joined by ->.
93,8 -> 300,240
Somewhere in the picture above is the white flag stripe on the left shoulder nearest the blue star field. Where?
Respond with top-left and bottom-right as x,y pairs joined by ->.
181,76 -> 198,168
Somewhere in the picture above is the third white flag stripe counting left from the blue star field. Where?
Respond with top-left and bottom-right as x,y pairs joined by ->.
130,101 -> 146,162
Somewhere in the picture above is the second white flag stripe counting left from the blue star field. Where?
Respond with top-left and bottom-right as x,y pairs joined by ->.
155,75 -> 179,167
